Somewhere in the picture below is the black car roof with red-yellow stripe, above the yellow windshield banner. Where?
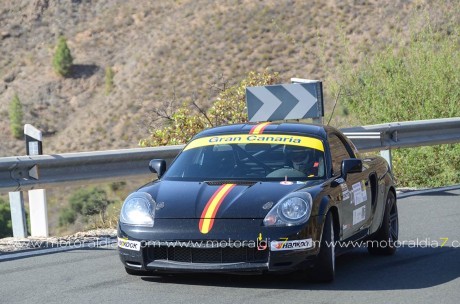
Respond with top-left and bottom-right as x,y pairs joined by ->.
194,122 -> 337,139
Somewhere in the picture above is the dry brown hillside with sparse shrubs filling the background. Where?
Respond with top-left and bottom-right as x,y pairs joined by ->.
0,0 -> 458,156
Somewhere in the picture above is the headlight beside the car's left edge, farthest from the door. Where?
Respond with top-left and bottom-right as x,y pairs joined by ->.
120,192 -> 155,227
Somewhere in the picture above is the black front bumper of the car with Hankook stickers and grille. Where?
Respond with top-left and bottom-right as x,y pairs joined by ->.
118,217 -> 321,274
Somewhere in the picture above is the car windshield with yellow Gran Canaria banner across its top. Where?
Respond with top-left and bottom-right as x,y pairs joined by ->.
163,134 -> 325,181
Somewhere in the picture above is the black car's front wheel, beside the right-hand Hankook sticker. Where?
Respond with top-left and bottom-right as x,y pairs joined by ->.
311,212 -> 335,282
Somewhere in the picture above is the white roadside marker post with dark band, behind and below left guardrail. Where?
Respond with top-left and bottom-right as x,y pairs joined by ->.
24,124 -> 49,237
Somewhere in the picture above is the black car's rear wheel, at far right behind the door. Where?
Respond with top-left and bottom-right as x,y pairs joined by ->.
367,191 -> 399,255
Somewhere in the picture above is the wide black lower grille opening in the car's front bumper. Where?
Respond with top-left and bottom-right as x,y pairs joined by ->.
147,246 -> 268,263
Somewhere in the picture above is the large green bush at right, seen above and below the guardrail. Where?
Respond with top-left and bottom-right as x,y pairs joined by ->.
332,17 -> 460,187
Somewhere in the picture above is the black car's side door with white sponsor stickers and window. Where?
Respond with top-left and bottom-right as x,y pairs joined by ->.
328,133 -> 371,239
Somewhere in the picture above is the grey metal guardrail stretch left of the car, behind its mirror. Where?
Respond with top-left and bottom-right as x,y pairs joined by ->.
0,145 -> 184,191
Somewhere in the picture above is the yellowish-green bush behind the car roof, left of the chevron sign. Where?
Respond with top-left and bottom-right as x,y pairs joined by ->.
139,71 -> 279,147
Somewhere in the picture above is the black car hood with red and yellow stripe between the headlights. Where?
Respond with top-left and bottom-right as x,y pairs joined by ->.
138,180 -> 319,219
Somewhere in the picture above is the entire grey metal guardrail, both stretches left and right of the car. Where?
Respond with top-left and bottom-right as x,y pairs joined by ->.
0,117 -> 460,192
